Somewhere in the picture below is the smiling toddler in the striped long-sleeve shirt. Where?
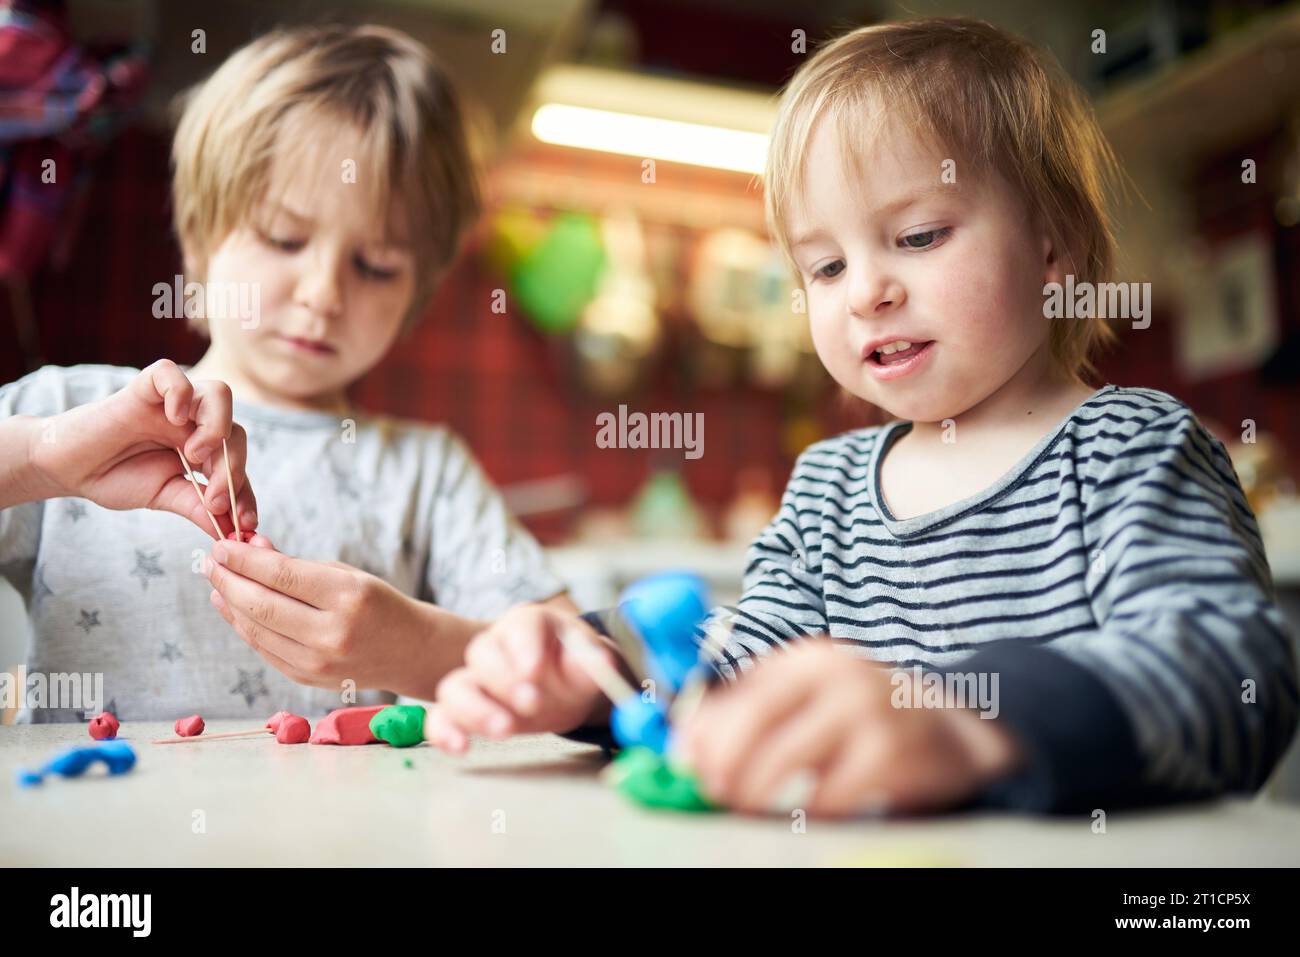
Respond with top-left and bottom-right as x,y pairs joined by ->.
436,18 -> 1296,815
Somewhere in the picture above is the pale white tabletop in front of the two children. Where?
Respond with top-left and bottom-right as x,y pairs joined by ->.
0,722 -> 1300,866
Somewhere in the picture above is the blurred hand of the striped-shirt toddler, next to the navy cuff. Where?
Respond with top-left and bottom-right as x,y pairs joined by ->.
681,638 -> 1019,817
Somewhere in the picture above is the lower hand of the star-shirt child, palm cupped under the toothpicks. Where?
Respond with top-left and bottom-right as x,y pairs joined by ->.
204,536 -> 482,698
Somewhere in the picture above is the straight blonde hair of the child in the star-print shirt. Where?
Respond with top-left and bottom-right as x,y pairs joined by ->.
172,26 -> 481,328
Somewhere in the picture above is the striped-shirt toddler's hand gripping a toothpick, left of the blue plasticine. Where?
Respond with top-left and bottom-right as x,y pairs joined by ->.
425,605 -> 618,754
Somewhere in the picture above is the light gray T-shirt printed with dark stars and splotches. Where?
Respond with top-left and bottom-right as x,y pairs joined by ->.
0,365 -> 564,723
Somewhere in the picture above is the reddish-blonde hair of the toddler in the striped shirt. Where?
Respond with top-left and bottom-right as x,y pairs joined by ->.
764,17 -> 1122,377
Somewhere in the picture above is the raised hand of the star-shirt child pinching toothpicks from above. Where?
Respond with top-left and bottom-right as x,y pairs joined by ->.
29,359 -> 257,534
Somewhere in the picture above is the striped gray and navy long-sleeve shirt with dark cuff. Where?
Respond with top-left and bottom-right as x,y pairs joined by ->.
691,386 -> 1296,810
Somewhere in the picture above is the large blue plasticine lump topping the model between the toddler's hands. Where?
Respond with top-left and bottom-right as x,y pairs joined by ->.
619,572 -> 709,693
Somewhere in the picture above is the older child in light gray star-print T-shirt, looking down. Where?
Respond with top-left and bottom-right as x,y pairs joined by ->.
0,26 -> 572,720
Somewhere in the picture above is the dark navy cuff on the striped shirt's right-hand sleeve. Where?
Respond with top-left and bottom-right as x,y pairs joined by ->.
948,640 -> 1143,813
